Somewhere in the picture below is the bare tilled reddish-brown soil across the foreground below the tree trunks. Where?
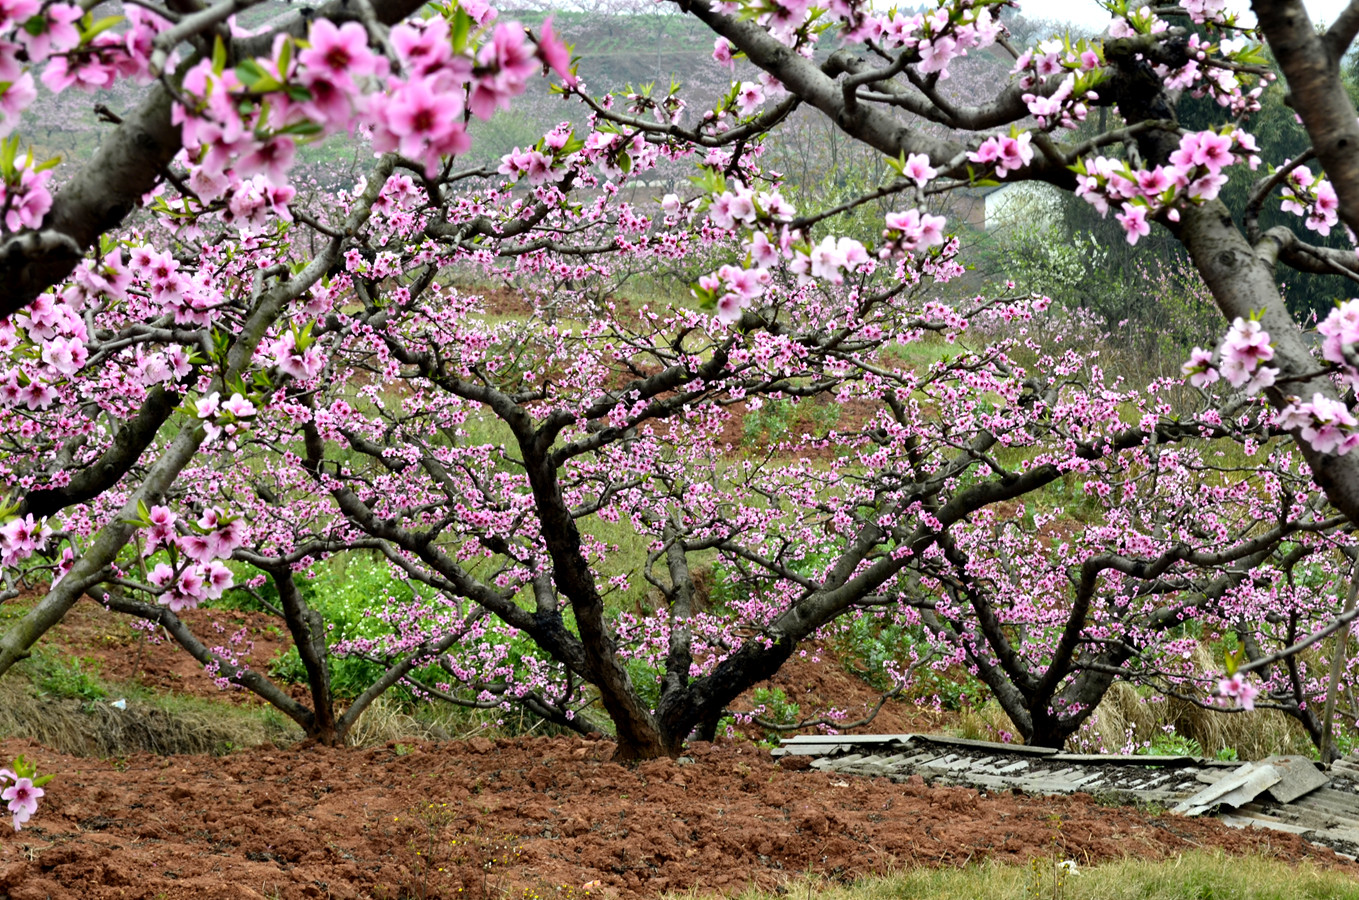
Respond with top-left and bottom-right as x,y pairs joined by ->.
0,738 -> 1359,900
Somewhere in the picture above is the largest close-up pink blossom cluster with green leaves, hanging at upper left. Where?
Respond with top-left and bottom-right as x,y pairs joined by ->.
174,8 -> 569,209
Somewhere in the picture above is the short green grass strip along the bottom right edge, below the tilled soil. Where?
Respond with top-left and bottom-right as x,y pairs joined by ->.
712,851 -> 1359,900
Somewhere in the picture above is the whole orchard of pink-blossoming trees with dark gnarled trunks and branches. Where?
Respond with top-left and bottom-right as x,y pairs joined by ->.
0,0 -> 1359,824
